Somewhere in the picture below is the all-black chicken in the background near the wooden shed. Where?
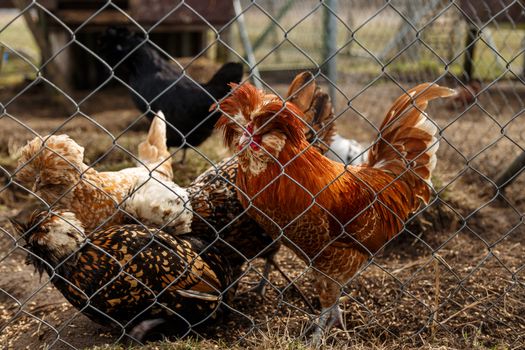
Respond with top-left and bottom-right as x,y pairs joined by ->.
100,28 -> 243,160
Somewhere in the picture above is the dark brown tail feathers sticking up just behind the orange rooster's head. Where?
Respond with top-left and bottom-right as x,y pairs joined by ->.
286,71 -> 335,154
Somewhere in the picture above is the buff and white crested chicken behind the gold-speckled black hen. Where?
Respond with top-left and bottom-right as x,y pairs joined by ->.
16,112 -> 192,232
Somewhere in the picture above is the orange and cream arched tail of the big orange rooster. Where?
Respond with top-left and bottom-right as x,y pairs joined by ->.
368,83 -> 455,203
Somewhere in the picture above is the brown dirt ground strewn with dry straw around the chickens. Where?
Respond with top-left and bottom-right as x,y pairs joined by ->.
0,73 -> 525,349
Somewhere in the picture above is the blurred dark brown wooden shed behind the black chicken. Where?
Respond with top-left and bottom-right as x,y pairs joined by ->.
0,0 -> 234,88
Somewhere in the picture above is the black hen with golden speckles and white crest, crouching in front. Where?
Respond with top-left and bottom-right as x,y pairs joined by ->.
12,211 -> 233,341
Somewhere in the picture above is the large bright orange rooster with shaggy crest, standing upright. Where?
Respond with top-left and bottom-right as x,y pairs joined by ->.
217,83 -> 455,341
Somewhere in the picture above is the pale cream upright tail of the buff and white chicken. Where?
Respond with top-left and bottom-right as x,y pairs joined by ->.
138,111 -> 173,180
